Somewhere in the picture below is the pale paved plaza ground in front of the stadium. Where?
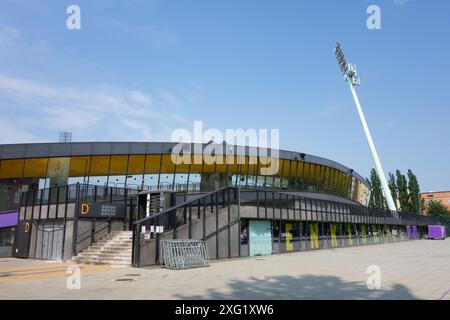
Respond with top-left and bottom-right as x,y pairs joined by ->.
0,239 -> 450,300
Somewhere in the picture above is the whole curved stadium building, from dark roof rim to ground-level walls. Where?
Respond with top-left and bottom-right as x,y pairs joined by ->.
0,142 -> 448,267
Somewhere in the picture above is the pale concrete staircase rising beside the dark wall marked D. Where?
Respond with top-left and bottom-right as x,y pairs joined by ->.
72,231 -> 133,266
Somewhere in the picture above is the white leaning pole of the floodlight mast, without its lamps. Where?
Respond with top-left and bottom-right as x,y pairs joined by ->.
347,77 -> 397,211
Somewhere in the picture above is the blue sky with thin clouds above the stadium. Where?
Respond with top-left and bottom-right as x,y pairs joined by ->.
0,0 -> 450,191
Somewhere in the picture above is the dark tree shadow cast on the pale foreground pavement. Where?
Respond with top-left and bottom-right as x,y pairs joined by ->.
177,275 -> 418,300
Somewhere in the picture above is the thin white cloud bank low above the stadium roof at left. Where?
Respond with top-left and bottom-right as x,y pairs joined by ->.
0,74 -> 190,143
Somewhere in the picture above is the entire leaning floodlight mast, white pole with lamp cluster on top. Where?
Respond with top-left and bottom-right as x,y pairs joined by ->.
334,42 -> 397,211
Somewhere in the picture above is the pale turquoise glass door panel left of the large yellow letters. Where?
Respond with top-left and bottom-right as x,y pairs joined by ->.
249,220 -> 272,256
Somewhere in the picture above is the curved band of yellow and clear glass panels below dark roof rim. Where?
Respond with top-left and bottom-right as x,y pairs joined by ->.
0,154 -> 370,205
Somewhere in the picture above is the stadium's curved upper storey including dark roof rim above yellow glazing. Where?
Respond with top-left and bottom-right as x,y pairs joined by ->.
0,142 -> 370,211
